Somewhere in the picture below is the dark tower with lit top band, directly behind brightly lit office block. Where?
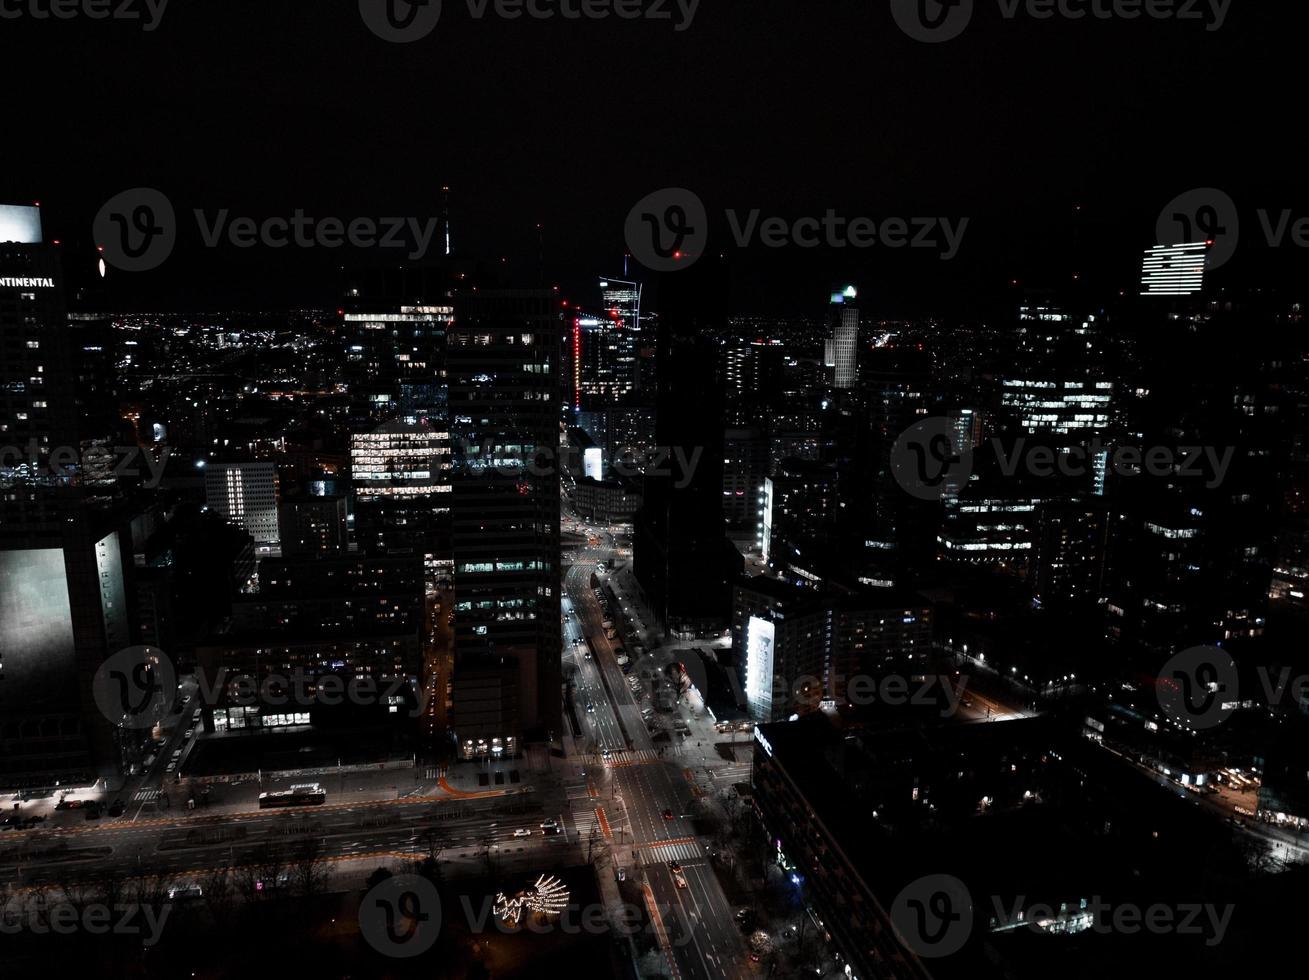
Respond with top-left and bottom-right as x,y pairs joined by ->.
342,305 -> 454,429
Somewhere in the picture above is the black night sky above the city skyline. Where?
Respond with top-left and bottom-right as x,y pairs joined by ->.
0,0 -> 1309,317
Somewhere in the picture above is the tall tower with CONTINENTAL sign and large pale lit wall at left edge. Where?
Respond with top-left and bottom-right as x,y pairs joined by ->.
0,205 -> 131,786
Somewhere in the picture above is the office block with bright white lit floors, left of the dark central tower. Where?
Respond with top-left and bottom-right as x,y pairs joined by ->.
350,419 -> 453,589
